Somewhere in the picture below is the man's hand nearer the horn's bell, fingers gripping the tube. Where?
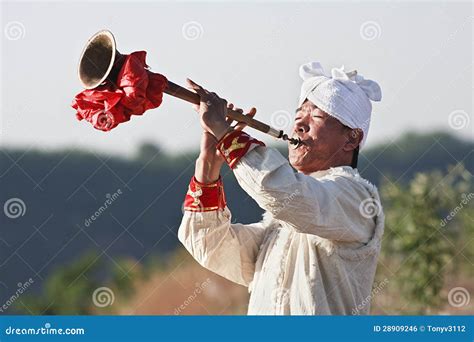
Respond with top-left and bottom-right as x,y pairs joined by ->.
187,78 -> 231,140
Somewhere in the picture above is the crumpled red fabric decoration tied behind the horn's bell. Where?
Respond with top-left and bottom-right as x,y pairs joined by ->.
72,51 -> 168,131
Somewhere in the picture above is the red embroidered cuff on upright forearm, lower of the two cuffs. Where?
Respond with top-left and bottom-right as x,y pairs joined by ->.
184,176 -> 226,212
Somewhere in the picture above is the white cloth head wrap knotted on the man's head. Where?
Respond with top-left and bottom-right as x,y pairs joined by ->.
298,62 -> 382,147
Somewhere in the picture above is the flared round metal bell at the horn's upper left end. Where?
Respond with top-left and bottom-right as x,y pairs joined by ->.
78,30 -> 123,89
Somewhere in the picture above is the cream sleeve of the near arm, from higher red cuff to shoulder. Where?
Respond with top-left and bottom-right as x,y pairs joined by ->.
234,146 -> 375,243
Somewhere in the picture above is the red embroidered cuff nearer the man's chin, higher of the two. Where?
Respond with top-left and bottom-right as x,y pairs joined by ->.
217,131 -> 265,169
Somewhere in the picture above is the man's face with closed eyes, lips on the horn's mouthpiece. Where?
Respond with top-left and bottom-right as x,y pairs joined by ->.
289,101 -> 352,174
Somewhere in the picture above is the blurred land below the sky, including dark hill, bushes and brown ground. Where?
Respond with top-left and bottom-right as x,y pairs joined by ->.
0,133 -> 474,315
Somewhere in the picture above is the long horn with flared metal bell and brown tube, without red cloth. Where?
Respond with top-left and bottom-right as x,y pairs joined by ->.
78,30 -> 300,145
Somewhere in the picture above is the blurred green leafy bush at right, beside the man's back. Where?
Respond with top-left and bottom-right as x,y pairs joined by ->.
381,164 -> 474,313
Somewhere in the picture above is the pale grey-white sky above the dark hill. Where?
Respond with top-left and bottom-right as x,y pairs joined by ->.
0,1 -> 474,156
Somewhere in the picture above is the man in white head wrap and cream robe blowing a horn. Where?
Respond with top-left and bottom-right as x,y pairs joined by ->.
178,62 -> 384,315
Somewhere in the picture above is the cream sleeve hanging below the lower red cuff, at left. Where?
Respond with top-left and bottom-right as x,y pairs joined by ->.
178,207 -> 265,286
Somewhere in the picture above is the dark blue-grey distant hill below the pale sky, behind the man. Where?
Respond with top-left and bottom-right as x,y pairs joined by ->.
0,133 -> 474,313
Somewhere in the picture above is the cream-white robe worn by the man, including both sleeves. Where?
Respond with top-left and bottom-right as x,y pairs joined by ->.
178,146 -> 384,315
